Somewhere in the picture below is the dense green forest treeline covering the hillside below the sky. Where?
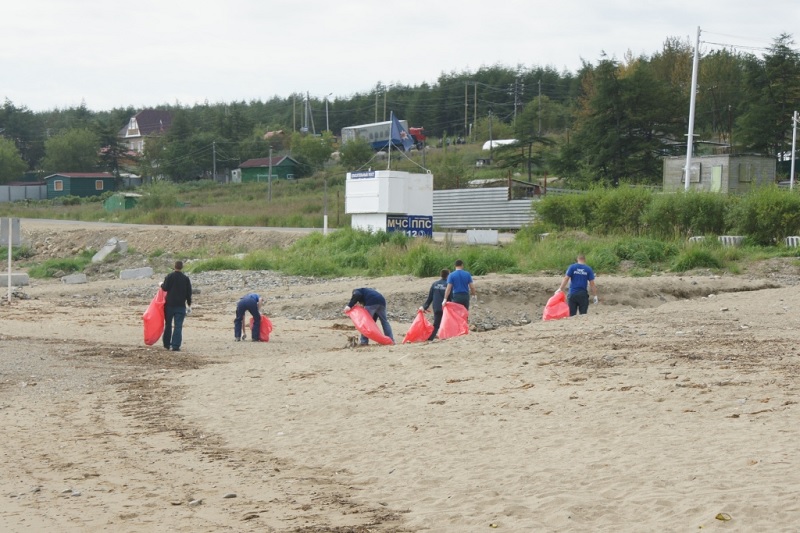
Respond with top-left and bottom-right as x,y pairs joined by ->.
0,34 -> 800,187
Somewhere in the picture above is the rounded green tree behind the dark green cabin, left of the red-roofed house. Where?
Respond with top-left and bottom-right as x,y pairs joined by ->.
42,129 -> 100,172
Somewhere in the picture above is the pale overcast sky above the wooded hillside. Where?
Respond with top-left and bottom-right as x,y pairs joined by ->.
0,0 -> 800,111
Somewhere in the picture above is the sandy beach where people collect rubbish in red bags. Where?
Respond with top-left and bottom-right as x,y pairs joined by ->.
0,222 -> 800,533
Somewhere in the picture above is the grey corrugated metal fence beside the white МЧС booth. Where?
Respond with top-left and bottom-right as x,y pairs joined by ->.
433,187 -> 536,230
